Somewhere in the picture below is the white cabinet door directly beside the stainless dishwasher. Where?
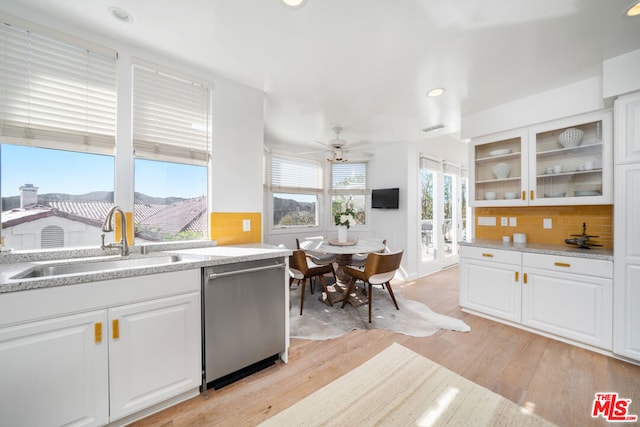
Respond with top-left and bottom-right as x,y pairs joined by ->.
109,292 -> 202,420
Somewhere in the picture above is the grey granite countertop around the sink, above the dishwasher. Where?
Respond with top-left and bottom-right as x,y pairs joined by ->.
0,244 -> 292,295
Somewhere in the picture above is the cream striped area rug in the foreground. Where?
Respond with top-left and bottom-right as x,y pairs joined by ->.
261,343 -> 554,427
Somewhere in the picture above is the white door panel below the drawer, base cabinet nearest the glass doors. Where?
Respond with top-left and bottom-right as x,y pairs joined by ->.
460,258 -> 521,322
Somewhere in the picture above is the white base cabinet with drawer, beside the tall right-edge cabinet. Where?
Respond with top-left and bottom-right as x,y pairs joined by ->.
522,253 -> 613,350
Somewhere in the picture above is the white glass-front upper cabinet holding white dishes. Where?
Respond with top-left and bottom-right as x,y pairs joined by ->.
471,111 -> 613,206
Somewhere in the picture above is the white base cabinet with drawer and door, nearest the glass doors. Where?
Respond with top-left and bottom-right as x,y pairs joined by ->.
460,246 -> 521,322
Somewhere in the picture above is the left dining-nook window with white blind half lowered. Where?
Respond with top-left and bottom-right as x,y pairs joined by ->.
271,156 -> 323,228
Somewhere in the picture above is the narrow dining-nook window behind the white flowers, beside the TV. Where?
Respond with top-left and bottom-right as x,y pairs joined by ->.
329,162 -> 371,225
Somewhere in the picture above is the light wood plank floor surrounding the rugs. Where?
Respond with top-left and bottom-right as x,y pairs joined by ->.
135,267 -> 640,426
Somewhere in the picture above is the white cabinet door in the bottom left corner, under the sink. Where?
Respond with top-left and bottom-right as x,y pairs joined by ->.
0,310 -> 109,426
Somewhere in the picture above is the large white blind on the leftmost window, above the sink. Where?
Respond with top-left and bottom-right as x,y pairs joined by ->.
0,22 -> 117,153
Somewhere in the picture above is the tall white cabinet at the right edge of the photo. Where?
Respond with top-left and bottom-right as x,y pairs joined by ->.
613,92 -> 640,361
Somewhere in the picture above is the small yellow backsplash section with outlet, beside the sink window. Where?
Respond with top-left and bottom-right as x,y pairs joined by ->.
211,212 -> 262,245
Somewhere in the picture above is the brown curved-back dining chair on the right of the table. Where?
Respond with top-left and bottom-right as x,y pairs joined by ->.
342,250 -> 403,323
